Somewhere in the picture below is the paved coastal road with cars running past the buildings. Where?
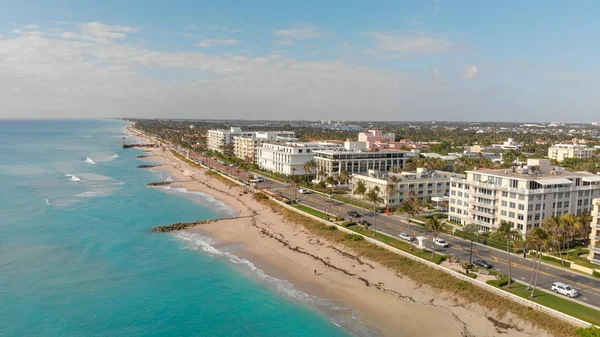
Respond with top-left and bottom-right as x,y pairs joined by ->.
260,181 -> 600,309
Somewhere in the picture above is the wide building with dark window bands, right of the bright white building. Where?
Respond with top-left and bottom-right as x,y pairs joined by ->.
315,142 -> 414,178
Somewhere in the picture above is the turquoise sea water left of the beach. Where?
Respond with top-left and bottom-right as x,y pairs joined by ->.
0,120 -> 369,337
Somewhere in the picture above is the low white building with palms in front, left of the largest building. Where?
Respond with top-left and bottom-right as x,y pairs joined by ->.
350,168 -> 465,206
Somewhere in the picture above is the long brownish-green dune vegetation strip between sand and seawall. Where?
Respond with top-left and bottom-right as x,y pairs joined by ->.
256,193 -> 575,336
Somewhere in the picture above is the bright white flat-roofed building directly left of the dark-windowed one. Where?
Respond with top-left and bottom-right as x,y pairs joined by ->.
256,142 -> 341,175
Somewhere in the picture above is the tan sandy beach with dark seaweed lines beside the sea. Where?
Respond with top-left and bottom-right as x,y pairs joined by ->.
141,149 -> 547,337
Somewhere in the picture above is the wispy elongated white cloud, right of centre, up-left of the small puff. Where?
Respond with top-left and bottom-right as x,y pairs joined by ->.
364,32 -> 454,55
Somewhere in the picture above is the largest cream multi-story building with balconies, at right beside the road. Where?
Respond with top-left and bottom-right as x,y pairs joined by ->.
448,159 -> 600,234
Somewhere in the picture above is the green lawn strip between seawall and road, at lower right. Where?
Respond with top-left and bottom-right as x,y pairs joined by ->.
501,283 -> 600,325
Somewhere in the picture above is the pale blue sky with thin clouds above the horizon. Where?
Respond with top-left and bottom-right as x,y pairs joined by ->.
0,0 -> 600,122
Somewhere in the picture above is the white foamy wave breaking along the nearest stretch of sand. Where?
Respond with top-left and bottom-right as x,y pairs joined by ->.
173,231 -> 380,337
